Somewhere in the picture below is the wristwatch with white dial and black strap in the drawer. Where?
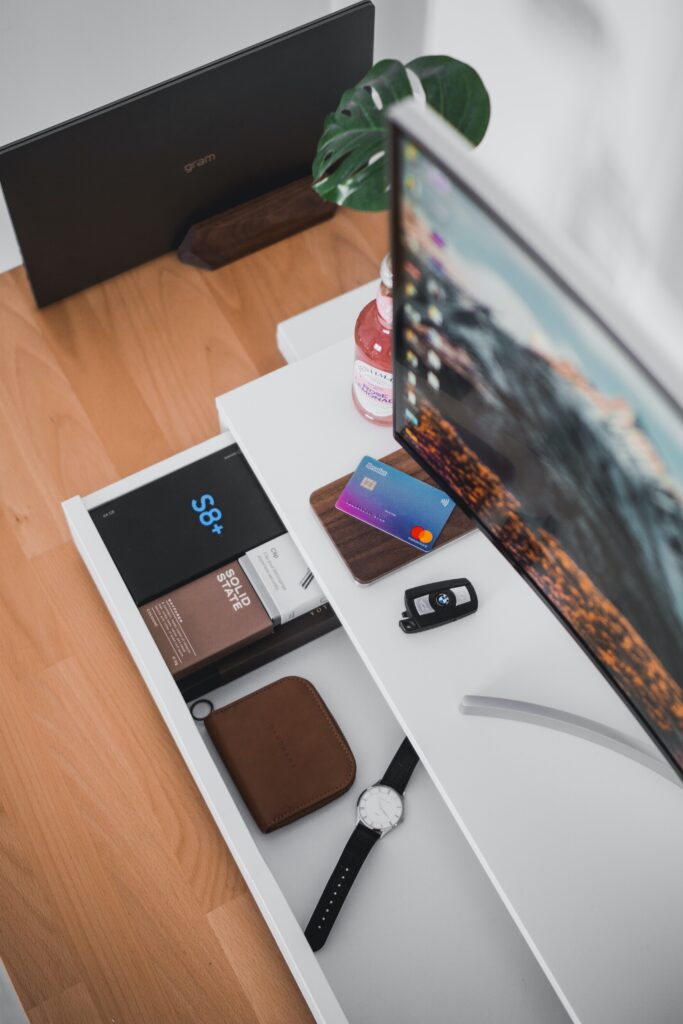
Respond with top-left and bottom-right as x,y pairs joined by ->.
305,737 -> 420,951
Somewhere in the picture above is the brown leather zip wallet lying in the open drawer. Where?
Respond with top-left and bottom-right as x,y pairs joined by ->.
204,676 -> 355,833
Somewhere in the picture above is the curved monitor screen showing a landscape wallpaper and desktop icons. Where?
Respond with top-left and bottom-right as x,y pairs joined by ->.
393,114 -> 683,775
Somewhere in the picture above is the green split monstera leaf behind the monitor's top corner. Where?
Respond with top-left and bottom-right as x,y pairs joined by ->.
313,56 -> 490,210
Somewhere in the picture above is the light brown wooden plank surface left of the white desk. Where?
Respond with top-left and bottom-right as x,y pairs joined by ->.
0,211 -> 387,1024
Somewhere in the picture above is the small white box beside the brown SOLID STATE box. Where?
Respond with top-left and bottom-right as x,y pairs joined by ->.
239,534 -> 326,626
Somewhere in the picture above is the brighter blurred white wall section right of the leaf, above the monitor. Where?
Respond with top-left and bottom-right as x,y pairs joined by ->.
411,0 -> 683,356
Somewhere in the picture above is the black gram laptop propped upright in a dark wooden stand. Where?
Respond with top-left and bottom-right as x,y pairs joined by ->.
0,0 -> 375,306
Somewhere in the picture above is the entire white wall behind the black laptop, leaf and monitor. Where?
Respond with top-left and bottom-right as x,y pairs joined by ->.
0,0 -> 683,348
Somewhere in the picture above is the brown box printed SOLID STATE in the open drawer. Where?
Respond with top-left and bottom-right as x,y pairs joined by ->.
140,562 -> 273,679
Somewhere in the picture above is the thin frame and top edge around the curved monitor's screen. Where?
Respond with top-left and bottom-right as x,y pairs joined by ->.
388,99 -> 683,779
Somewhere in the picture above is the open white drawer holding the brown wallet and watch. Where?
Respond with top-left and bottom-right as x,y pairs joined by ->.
63,432 -> 567,1024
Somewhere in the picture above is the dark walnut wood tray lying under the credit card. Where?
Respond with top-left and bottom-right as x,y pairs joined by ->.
309,449 -> 476,584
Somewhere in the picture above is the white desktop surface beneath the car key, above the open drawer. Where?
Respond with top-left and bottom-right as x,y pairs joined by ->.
218,340 -> 683,1024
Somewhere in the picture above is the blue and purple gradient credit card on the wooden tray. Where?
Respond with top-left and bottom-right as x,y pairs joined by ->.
335,456 -> 456,551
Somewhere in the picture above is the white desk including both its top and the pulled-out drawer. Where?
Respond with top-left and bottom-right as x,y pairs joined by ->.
65,285 -> 683,1024
